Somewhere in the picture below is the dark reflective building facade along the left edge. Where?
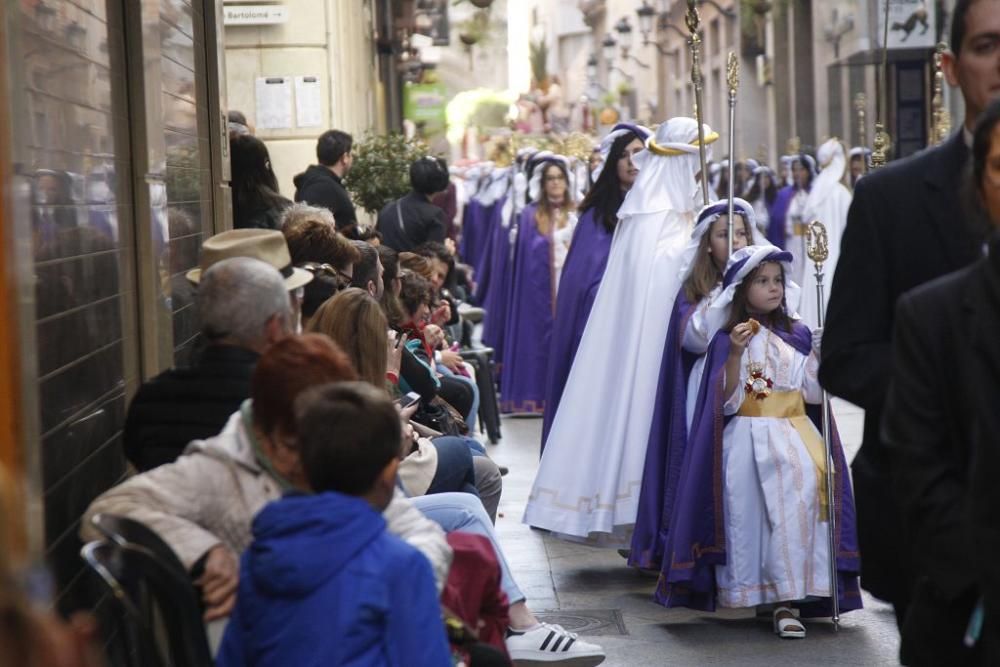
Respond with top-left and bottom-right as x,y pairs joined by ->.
0,0 -> 230,610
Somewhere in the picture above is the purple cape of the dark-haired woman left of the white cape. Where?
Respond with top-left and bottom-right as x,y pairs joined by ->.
542,208 -> 614,449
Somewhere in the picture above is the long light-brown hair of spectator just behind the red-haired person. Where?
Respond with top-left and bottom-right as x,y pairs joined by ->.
307,287 -> 389,389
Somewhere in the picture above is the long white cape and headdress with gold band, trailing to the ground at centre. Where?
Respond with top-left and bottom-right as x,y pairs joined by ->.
524,118 -> 718,545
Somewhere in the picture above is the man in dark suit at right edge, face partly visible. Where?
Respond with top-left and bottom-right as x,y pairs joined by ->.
820,0 -> 1000,624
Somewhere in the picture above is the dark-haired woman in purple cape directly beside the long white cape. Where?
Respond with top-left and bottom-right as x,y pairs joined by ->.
542,123 -> 650,448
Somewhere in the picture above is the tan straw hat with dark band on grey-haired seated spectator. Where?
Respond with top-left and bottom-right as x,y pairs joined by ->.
186,229 -> 313,290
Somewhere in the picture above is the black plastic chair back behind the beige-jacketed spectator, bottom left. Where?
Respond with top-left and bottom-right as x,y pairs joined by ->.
80,540 -> 214,667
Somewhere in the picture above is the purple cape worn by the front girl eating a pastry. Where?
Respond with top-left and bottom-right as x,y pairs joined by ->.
655,323 -> 861,617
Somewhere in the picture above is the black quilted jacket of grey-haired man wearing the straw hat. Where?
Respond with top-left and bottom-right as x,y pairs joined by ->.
122,345 -> 259,471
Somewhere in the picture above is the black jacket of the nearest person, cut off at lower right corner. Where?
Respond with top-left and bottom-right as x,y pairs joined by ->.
884,246 -> 1000,665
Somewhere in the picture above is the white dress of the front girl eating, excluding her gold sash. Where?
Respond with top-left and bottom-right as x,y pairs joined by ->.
716,327 -> 830,607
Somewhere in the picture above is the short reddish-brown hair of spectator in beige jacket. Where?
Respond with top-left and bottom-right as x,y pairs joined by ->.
250,333 -> 360,435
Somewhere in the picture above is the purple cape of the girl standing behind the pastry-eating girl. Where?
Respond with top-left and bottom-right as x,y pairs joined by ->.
628,288 -> 698,570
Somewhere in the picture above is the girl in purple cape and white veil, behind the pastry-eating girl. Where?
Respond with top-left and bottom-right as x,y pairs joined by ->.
629,198 -> 757,569
